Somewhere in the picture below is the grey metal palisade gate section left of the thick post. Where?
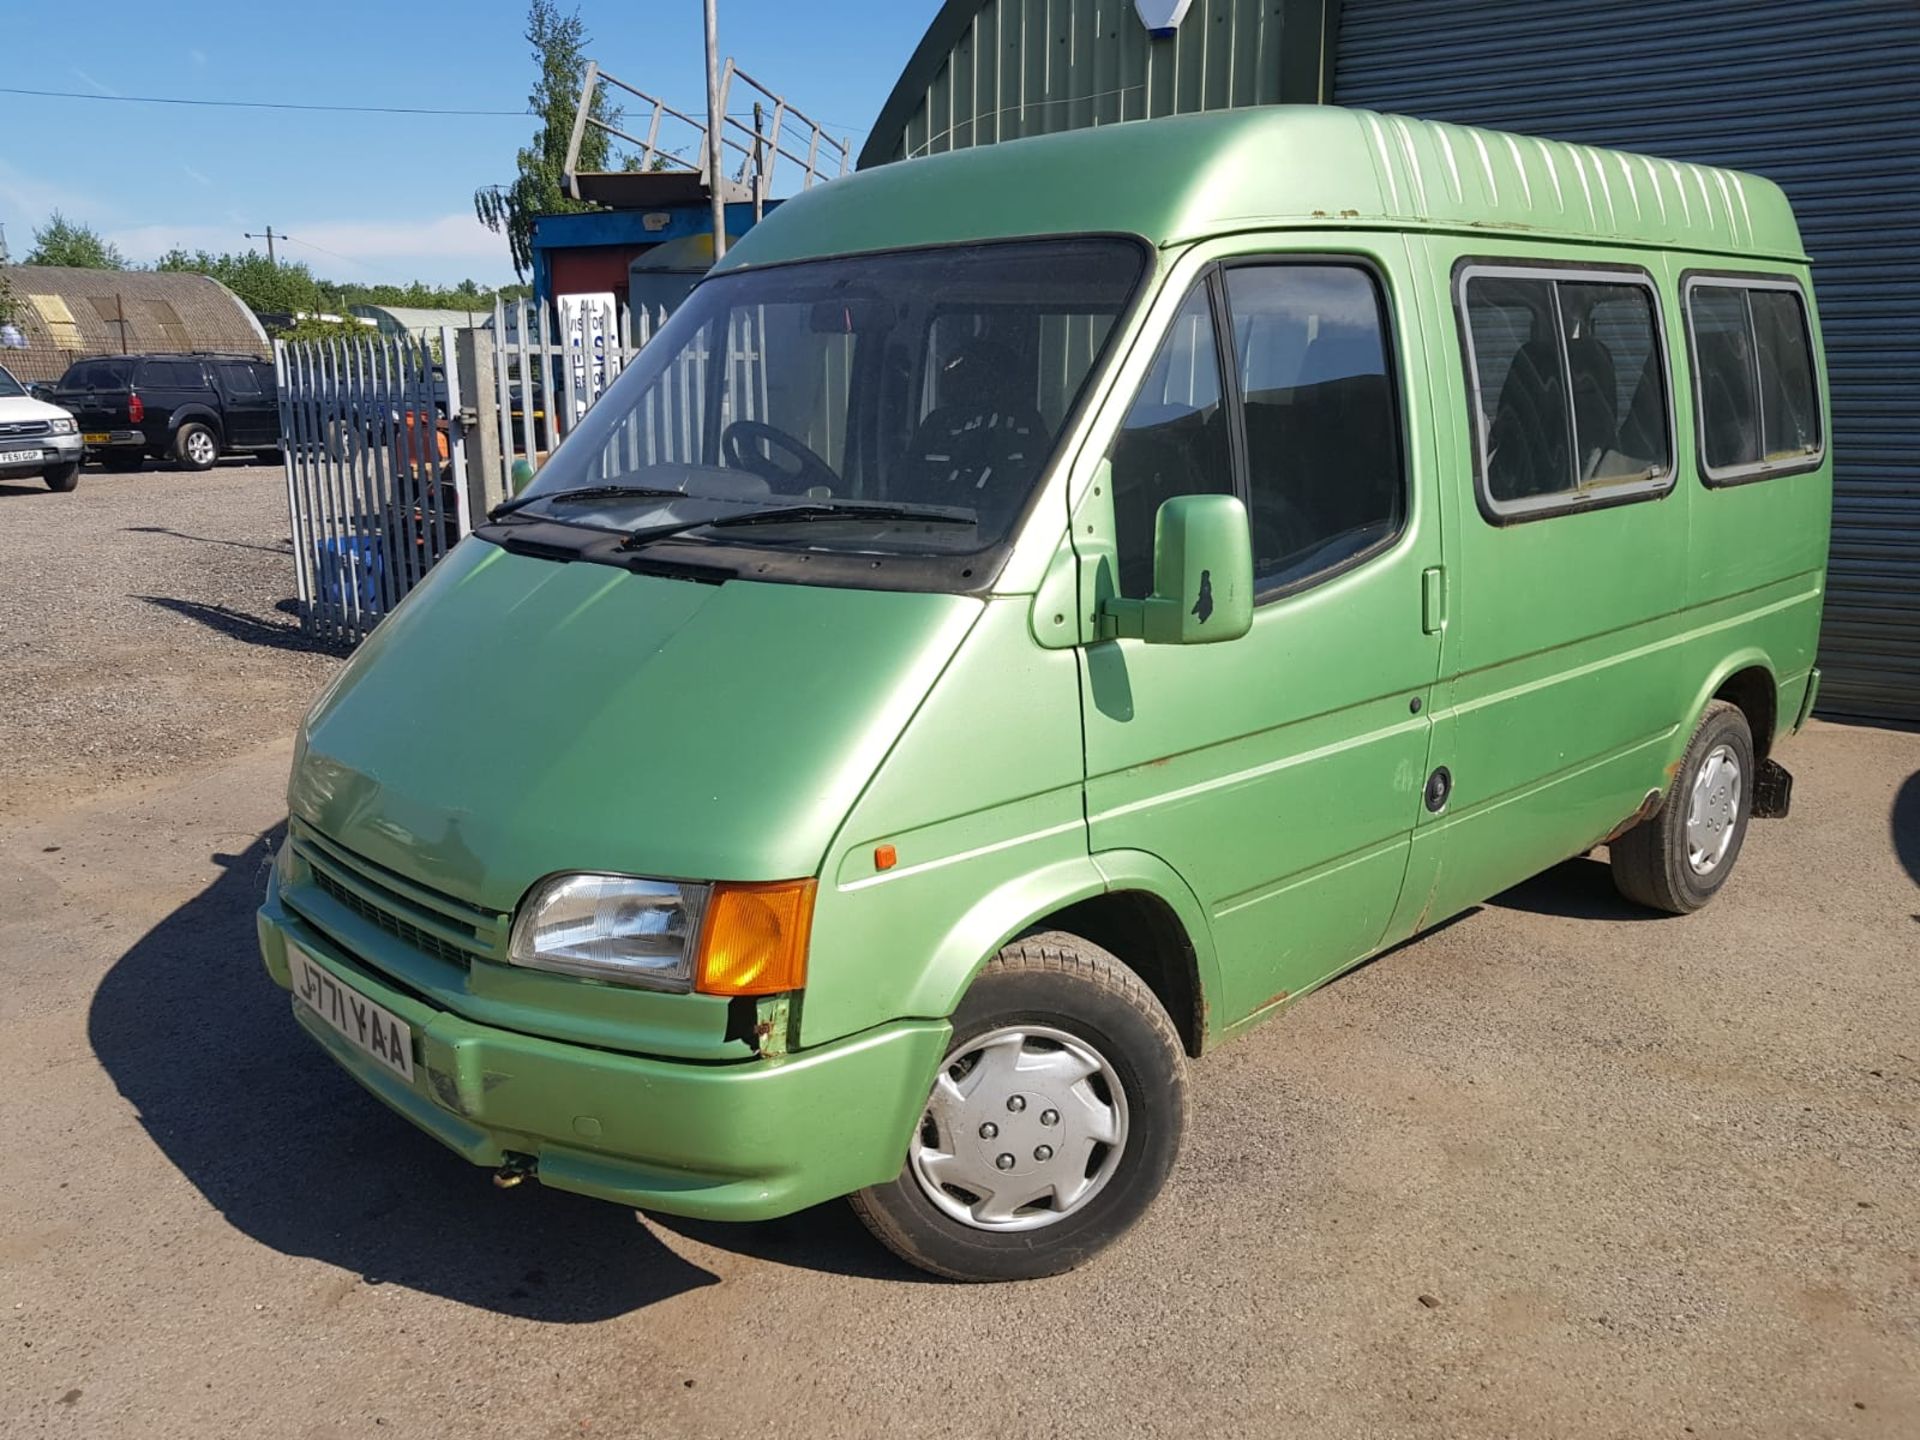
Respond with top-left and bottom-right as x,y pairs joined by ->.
273,330 -> 472,641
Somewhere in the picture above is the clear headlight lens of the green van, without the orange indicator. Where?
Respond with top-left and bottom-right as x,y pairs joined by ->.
507,876 -> 707,991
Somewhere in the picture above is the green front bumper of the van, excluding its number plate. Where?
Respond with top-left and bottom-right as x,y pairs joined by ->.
259,883 -> 950,1221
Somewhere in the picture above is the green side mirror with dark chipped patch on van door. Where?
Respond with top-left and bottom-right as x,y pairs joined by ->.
1100,495 -> 1254,645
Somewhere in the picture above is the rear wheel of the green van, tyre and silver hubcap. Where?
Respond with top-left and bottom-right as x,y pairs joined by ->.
1609,701 -> 1755,916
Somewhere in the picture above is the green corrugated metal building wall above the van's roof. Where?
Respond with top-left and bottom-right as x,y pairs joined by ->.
887,0 -> 1290,159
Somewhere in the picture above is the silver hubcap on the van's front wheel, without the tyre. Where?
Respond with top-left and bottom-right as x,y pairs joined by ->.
908,1025 -> 1127,1231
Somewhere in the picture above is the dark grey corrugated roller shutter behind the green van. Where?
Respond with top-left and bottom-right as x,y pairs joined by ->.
1334,0 -> 1920,720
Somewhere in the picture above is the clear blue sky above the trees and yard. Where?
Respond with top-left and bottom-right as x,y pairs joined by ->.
0,0 -> 937,284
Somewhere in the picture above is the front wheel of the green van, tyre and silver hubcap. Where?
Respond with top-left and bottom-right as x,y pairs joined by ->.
852,931 -> 1187,1281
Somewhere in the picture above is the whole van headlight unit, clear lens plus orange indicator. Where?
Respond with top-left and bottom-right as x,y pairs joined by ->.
507,874 -> 814,995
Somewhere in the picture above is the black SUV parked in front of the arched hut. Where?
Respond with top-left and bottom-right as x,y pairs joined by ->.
54,353 -> 280,470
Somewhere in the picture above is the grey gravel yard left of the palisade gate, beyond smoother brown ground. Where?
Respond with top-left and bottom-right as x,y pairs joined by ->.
0,463 -> 340,816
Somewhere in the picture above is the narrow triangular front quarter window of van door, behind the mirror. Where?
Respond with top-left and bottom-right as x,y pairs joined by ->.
1110,280 -> 1233,599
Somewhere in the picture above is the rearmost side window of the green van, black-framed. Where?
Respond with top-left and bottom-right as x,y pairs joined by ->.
1686,278 -> 1822,484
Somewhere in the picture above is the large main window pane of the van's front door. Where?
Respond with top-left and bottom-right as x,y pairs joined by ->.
1227,265 -> 1405,589
